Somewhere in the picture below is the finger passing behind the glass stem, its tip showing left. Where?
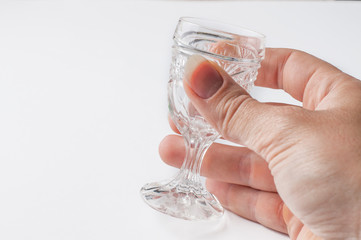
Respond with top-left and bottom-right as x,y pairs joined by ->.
159,135 -> 276,192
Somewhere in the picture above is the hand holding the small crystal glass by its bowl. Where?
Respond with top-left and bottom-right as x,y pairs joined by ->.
160,49 -> 361,240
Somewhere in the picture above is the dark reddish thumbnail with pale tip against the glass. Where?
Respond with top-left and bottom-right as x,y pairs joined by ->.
184,55 -> 223,99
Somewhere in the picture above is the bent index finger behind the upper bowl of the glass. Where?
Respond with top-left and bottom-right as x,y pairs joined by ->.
256,48 -> 348,110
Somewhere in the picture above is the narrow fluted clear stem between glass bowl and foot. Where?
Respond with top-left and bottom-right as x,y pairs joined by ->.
180,137 -> 213,185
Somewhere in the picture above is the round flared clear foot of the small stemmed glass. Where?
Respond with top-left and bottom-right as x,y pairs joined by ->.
140,173 -> 224,220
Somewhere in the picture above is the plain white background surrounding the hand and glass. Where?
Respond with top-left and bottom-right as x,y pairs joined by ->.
0,0 -> 361,240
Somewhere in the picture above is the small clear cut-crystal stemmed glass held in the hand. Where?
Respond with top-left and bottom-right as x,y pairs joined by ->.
140,18 -> 265,220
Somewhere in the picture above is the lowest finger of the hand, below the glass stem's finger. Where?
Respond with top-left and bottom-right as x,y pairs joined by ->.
207,179 -> 287,233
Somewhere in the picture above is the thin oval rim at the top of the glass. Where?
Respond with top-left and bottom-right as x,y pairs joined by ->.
179,16 -> 266,41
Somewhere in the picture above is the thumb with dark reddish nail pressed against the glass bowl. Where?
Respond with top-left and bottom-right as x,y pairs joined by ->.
183,55 -> 293,158
